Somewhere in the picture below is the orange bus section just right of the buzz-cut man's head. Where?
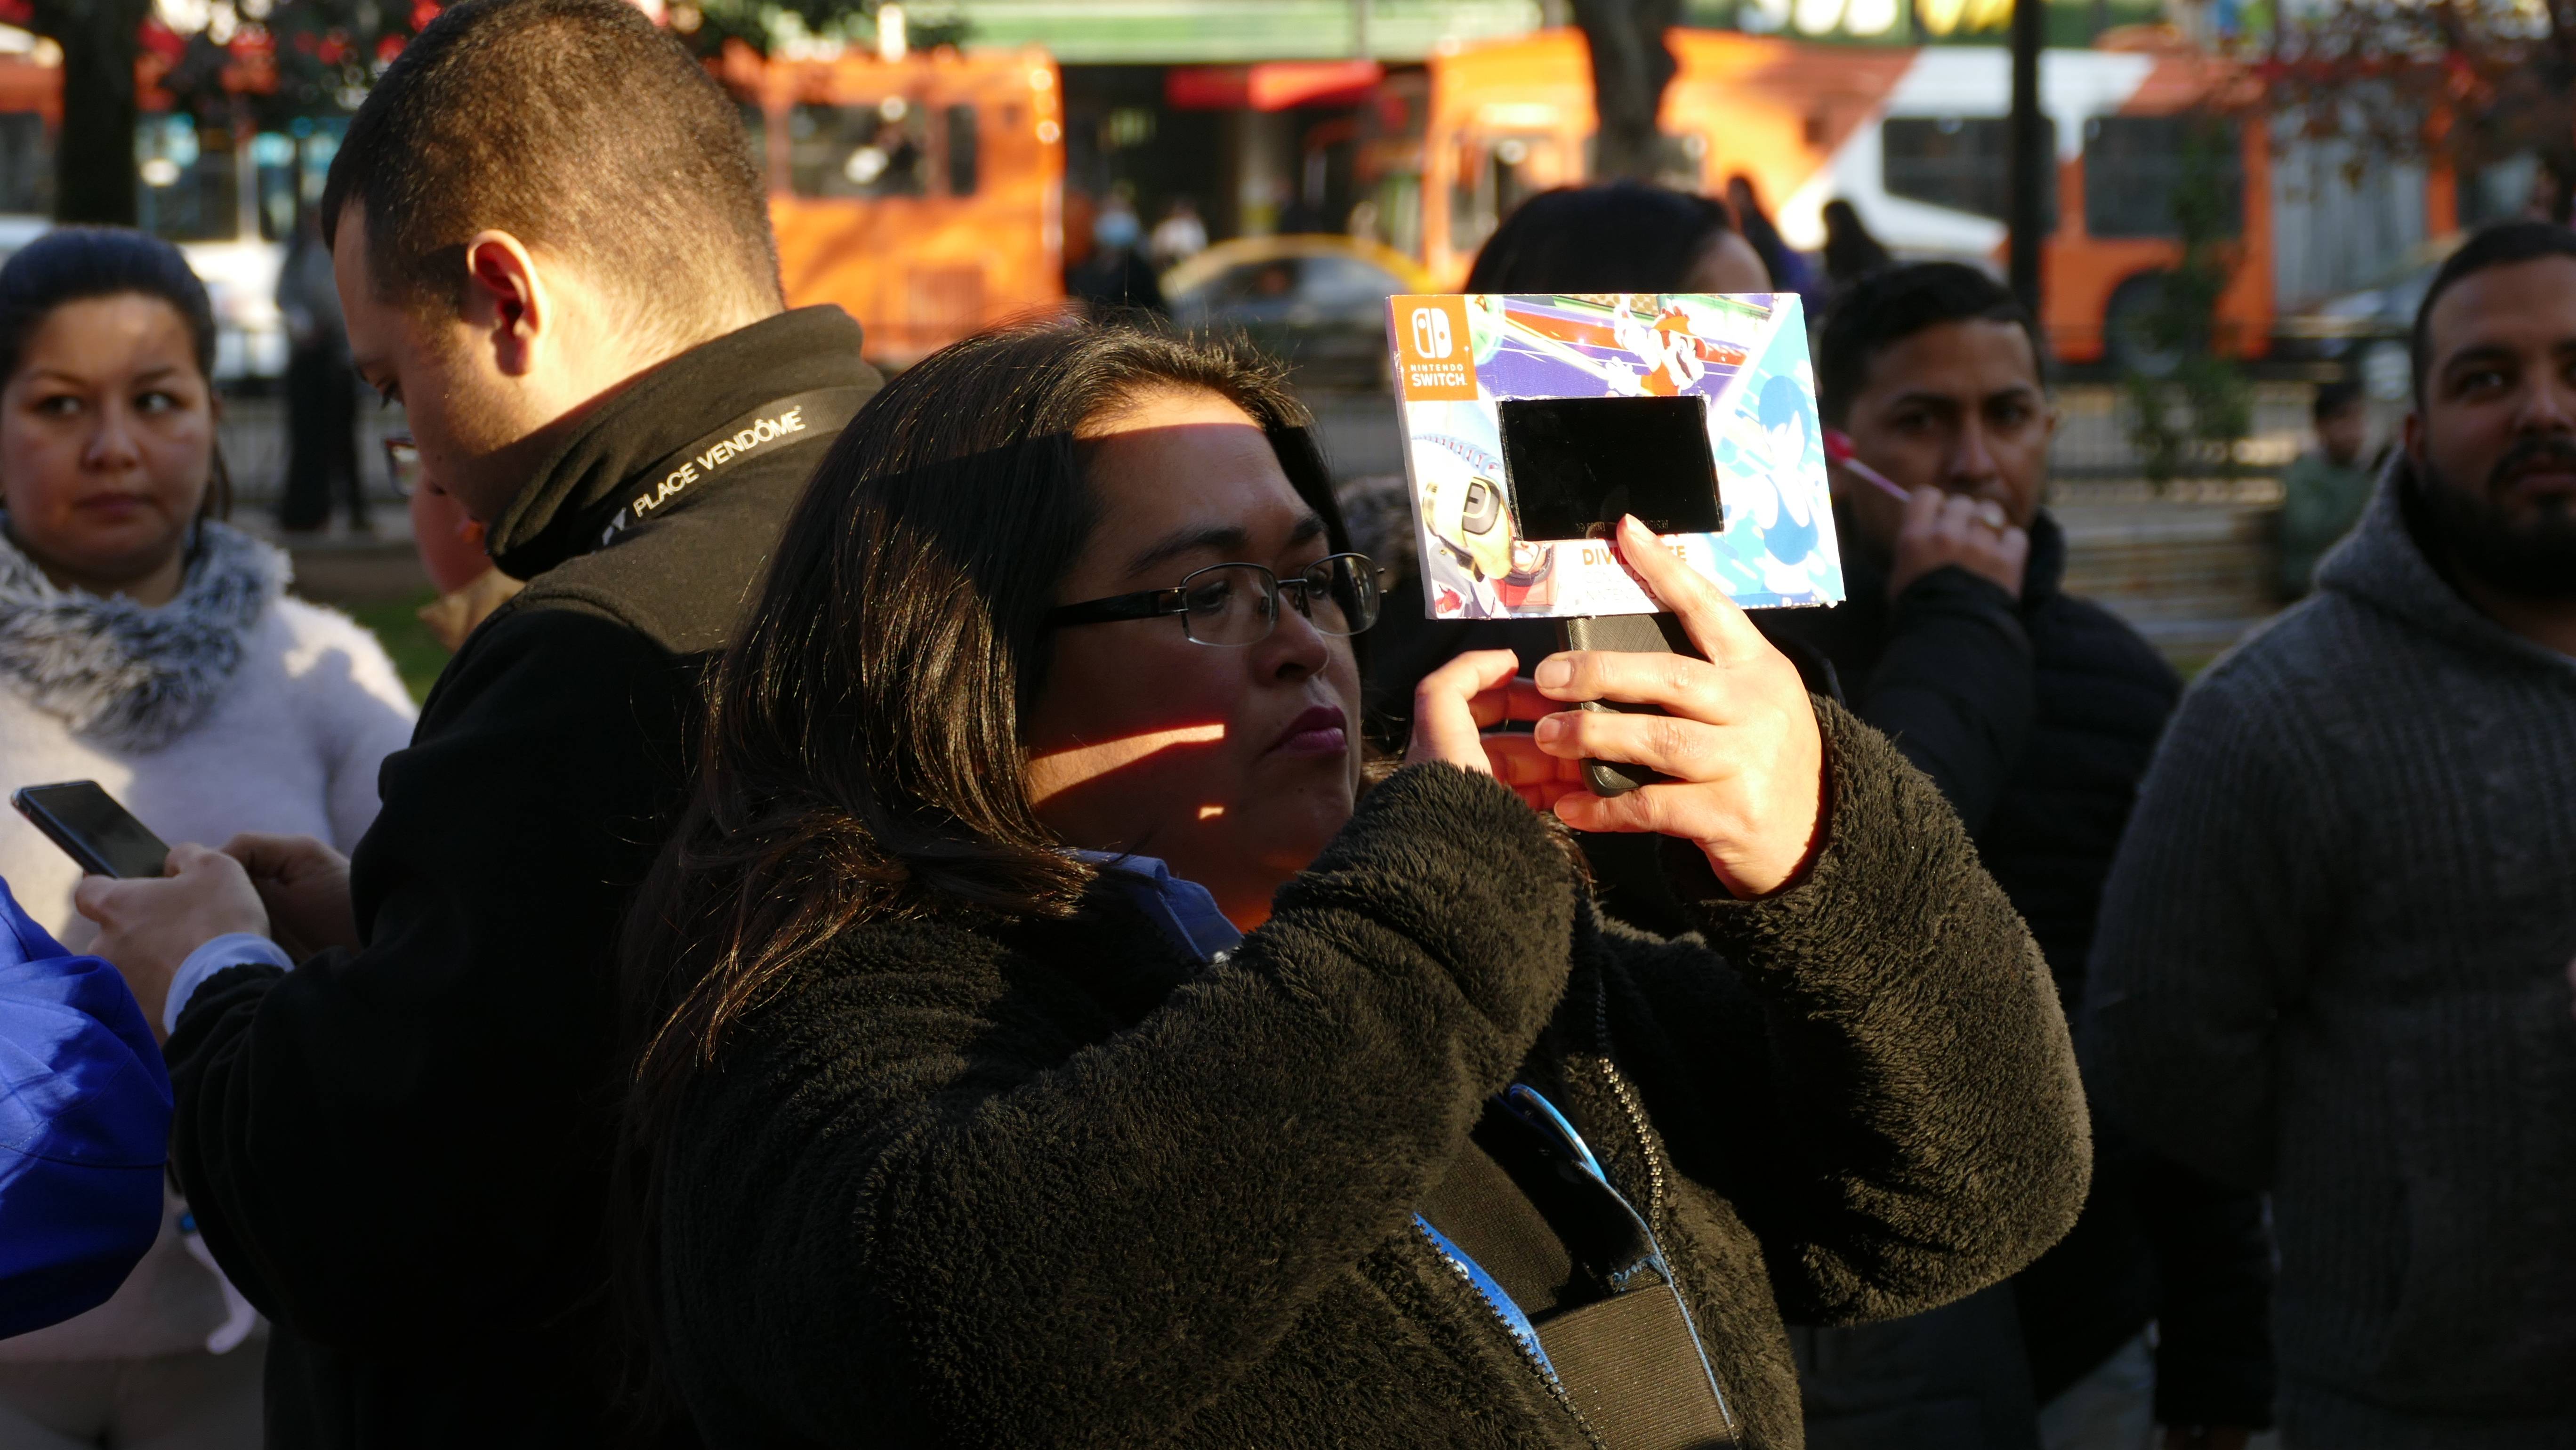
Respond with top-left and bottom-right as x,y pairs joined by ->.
719,44 -> 1064,366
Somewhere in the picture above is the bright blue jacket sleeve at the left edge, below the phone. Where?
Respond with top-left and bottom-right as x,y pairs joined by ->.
0,881 -> 170,1337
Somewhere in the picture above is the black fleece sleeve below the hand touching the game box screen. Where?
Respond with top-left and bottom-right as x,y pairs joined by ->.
1605,701 -> 2092,1324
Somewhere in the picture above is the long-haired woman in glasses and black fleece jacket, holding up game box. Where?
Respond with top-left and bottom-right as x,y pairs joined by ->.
623,324 -> 2086,1450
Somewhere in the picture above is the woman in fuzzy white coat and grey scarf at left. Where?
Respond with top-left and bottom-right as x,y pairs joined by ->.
0,226 -> 412,1450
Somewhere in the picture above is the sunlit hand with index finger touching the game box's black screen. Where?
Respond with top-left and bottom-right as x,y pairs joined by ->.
1525,515 -> 1824,899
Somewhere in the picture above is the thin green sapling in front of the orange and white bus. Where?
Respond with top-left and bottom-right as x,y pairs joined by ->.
2123,121 -> 2254,489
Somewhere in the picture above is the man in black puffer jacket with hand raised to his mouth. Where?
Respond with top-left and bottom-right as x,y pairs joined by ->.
1759,263 -> 2272,1450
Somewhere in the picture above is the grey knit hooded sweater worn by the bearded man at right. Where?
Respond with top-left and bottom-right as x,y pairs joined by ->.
2089,474 -> 2576,1450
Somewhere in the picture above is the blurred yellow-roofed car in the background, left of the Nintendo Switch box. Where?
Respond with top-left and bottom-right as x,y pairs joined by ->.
1162,234 -> 1432,389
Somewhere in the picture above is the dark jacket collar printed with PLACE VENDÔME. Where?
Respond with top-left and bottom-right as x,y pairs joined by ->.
490,306 -> 876,580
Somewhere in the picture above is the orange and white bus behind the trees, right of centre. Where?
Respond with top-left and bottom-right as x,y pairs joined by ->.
1358,28 -> 2452,361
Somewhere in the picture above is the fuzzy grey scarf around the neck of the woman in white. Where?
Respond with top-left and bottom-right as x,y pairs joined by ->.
0,518 -> 294,752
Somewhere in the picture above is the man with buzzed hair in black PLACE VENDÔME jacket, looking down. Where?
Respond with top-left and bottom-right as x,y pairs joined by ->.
65,0 -> 876,1450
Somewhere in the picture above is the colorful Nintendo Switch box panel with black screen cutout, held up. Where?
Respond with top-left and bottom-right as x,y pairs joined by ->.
1386,294 -> 1842,618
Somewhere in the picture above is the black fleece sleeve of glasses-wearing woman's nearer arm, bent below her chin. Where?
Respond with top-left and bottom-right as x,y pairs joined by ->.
662,765 -> 1577,1445
